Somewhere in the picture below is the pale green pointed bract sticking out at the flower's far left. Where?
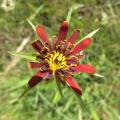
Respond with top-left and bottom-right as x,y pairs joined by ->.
9,51 -> 37,61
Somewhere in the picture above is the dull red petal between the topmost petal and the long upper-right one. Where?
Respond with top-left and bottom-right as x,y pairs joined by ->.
67,29 -> 80,44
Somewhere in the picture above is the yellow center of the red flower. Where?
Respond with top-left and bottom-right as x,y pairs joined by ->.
45,51 -> 67,71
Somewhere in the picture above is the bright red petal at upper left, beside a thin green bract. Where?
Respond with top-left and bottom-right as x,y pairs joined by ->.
36,25 -> 49,43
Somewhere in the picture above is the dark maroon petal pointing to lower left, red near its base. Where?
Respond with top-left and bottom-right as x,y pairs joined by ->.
28,71 -> 48,88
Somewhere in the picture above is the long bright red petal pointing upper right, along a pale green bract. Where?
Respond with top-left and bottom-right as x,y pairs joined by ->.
71,38 -> 92,54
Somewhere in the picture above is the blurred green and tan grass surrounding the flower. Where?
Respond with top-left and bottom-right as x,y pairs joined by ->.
0,0 -> 120,120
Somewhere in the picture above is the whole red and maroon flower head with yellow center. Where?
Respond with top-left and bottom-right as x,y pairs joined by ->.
28,21 -> 96,95
